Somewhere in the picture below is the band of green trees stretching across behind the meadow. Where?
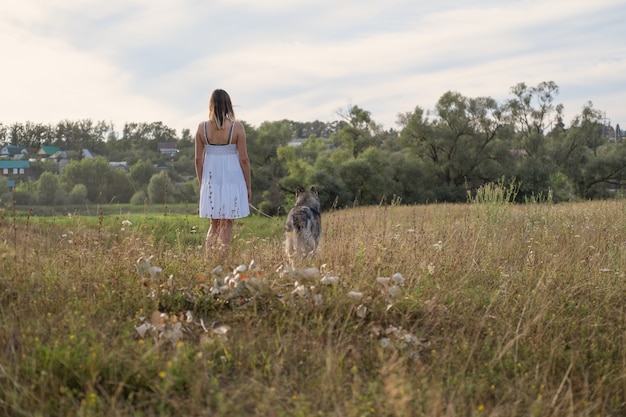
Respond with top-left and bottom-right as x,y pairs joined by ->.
0,81 -> 626,214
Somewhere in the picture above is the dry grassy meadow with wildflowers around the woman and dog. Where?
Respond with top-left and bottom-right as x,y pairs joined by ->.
0,190 -> 626,416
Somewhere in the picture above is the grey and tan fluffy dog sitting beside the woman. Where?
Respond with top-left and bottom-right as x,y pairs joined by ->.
285,186 -> 322,266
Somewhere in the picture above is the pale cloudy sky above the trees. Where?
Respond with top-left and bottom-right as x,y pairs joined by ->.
0,0 -> 626,133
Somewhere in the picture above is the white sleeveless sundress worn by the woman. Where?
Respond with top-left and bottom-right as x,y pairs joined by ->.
199,121 -> 250,219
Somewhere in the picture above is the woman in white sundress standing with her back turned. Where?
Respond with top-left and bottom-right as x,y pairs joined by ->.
196,89 -> 252,257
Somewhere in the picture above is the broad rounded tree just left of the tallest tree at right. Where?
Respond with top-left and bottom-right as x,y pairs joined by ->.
398,91 -> 512,198
